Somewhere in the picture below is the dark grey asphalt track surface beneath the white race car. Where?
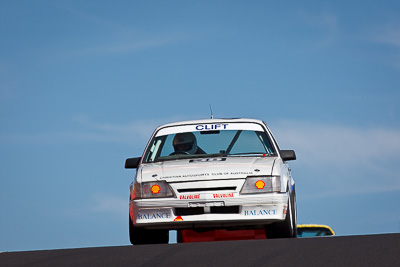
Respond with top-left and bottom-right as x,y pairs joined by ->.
0,234 -> 400,267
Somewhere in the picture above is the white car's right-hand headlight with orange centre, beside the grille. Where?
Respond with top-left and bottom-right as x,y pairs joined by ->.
240,176 -> 281,194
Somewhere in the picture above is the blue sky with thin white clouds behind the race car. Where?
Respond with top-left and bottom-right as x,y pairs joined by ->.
0,0 -> 400,251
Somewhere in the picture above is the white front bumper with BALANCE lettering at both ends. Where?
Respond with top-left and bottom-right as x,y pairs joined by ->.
130,193 -> 289,229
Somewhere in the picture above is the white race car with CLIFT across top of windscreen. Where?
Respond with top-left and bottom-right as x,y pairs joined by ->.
125,119 -> 297,245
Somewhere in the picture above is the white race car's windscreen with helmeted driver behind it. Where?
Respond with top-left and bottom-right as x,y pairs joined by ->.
144,130 -> 276,163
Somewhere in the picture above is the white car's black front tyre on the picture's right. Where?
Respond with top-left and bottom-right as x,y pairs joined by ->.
265,192 -> 297,239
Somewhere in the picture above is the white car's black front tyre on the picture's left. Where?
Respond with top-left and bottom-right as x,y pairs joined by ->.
129,217 -> 169,245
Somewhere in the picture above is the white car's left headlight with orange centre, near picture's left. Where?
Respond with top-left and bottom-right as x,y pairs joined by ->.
134,181 -> 173,198
